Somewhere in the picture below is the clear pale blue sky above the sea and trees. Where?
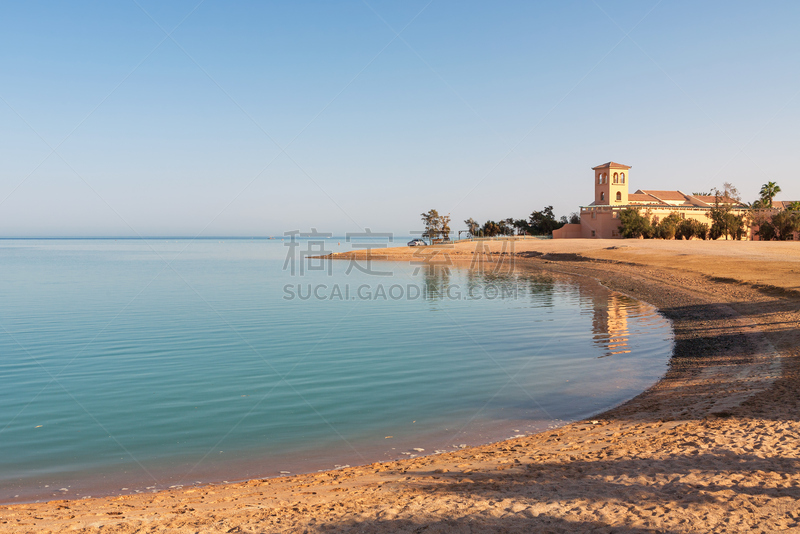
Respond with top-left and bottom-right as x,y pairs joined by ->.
0,0 -> 800,236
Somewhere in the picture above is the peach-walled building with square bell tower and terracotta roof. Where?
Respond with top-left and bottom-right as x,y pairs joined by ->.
553,161 -> 752,239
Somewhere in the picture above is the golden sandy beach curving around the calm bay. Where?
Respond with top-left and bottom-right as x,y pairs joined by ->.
0,240 -> 800,532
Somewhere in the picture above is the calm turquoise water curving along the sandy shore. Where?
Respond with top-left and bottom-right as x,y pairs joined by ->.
0,239 -> 672,502
